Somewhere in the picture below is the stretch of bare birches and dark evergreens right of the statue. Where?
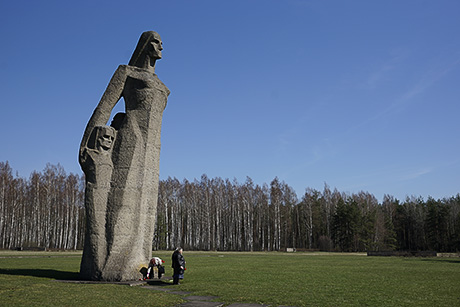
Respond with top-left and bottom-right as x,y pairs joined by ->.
154,175 -> 460,252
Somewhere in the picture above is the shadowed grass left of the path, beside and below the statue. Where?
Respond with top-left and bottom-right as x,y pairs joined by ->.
0,252 -> 183,306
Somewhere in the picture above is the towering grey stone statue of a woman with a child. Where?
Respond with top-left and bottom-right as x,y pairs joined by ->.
79,31 -> 170,281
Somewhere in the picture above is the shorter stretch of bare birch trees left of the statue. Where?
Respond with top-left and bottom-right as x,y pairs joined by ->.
0,162 -> 85,249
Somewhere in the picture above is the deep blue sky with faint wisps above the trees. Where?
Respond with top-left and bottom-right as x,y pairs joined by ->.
0,0 -> 460,201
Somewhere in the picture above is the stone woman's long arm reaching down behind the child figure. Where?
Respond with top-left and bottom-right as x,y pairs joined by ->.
79,65 -> 127,164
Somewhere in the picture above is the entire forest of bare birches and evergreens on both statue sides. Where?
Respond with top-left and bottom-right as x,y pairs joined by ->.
0,162 -> 460,252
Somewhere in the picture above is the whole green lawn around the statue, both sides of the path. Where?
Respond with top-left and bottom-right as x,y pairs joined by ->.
0,251 -> 460,306
